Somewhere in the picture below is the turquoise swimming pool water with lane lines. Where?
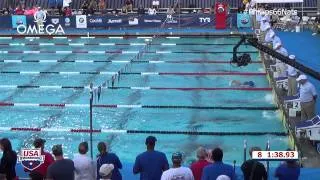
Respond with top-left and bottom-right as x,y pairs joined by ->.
0,37 -> 288,170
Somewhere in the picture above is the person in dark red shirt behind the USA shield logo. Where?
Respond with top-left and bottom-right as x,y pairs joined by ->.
25,138 -> 54,179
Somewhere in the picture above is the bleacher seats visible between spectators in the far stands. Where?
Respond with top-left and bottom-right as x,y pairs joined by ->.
0,0 -> 317,9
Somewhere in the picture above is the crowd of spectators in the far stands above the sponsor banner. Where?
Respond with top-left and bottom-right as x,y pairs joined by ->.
0,0 -> 228,16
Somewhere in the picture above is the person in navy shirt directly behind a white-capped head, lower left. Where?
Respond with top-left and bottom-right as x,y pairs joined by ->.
97,142 -> 122,180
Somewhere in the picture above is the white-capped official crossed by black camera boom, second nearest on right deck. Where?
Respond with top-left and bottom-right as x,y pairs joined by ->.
287,55 -> 298,96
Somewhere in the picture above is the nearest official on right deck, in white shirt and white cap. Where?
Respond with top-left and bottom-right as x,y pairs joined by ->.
297,74 -> 317,121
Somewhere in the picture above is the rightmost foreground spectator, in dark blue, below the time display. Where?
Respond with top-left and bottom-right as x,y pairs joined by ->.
275,153 -> 300,180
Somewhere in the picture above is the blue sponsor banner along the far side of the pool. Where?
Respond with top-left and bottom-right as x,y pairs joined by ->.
0,14 -> 234,29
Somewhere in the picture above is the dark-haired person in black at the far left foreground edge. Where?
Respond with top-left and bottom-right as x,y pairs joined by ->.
0,138 -> 17,180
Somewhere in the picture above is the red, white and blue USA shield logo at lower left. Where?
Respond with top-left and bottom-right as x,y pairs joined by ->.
18,149 -> 44,171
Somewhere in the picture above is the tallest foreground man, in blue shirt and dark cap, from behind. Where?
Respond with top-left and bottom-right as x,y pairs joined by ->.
133,136 -> 169,180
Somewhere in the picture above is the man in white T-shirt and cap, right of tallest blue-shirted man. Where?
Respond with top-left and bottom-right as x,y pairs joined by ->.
161,152 -> 194,180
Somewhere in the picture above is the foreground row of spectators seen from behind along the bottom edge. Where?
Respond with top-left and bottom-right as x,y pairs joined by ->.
0,136 -> 300,180
